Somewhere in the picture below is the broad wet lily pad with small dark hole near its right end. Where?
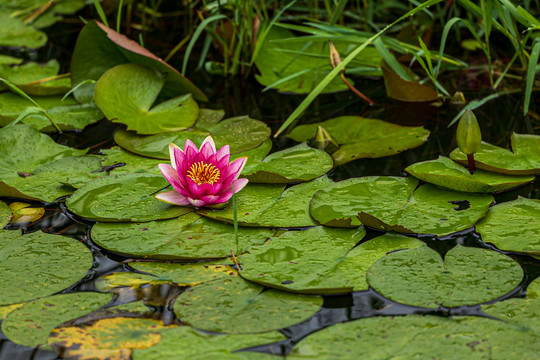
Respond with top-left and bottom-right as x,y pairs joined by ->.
310,176 -> 493,236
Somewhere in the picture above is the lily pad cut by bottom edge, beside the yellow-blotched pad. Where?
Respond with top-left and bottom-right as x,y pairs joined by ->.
133,326 -> 285,360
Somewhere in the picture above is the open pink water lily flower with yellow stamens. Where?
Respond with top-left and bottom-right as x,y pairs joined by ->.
156,136 -> 248,207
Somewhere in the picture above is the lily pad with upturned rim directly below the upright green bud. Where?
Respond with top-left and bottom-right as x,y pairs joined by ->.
405,156 -> 534,192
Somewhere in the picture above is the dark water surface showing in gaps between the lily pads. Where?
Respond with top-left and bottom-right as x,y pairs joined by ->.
0,76 -> 540,360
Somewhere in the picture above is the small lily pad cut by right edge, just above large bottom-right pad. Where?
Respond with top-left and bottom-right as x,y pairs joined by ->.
482,278 -> 540,335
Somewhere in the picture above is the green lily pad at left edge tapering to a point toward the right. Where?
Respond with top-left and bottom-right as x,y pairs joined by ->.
0,124 -> 86,178
